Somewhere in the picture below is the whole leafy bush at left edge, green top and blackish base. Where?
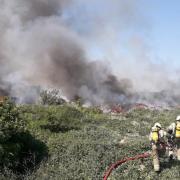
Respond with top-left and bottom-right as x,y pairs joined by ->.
0,100 -> 48,179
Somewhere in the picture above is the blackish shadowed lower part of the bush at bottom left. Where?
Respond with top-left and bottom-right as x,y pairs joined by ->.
0,132 -> 48,175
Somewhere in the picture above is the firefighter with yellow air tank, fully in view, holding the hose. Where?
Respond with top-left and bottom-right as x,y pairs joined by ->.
149,122 -> 166,172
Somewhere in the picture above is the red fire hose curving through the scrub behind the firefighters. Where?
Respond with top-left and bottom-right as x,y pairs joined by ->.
103,153 -> 151,180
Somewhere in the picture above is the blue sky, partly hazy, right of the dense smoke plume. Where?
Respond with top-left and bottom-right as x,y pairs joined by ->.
62,0 -> 180,71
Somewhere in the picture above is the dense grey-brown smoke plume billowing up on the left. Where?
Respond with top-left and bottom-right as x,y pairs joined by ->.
0,0 -> 131,103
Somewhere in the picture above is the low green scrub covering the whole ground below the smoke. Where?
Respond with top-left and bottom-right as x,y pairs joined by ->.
0,99 -> 180,180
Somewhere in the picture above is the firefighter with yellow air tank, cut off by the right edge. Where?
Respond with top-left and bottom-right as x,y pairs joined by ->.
167,115 -> 180,160
